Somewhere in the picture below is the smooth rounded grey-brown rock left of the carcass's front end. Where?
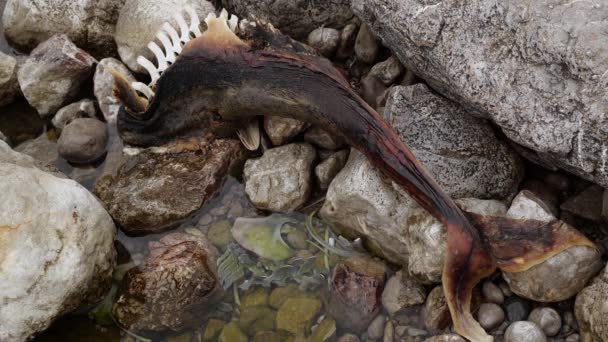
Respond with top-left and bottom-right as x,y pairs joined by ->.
57,118 -> 108,163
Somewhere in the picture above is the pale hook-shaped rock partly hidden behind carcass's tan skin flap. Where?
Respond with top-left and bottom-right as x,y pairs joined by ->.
93,57 -> 136,122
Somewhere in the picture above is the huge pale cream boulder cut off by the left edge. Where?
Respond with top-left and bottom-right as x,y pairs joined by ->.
0,160 -> 116,341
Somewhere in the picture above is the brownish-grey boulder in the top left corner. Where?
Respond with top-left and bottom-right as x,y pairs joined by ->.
2,0 -> 125,58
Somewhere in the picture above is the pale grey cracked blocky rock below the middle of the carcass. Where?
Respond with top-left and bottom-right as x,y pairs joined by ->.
243,143 -> 316,211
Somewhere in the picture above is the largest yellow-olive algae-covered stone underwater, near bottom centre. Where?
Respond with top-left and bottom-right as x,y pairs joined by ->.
277,298 -> 321,335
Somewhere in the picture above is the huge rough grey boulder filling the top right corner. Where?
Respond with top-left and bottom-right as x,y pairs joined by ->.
352,0 -> 608,186
